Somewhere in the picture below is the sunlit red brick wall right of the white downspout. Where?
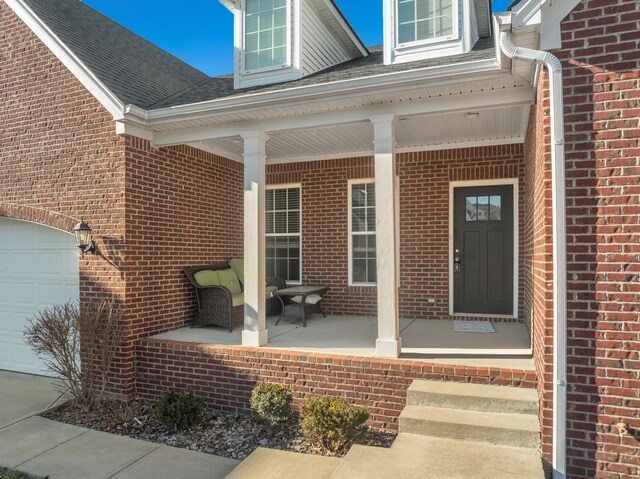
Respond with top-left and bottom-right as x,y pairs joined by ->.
527,0 -> 640,479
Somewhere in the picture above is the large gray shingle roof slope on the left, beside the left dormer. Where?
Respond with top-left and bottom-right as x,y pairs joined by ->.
24,0 -> 209,108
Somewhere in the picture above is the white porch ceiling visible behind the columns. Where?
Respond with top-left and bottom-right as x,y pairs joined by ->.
192,105 -> 529,163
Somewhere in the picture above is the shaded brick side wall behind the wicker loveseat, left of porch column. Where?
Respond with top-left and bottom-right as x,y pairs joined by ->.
125,137 -> 244,340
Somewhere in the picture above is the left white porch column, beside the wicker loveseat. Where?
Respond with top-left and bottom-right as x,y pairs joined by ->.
240,131 -> 269,347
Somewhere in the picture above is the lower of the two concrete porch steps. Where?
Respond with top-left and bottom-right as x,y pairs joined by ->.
399,406 -> 540,449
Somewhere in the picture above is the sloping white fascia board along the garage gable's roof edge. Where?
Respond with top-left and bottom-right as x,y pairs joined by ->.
5,0 -> 124,120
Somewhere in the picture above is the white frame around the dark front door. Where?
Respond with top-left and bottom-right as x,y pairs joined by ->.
449,178 -> 520,318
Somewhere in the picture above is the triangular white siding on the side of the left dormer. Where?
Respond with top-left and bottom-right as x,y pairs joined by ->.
301,1 -> 351,76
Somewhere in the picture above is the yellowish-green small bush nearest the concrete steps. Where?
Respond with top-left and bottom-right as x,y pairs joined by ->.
300,396 -> 369,453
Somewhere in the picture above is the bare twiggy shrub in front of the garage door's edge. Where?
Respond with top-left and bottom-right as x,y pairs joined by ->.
24,301 -> 124,410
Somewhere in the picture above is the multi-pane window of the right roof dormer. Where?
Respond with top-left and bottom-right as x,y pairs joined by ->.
397,0 -> 457,44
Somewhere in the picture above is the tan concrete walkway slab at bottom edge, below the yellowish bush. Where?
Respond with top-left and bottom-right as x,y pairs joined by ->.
225,447 -> 341,479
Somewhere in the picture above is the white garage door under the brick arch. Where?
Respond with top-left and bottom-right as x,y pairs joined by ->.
0,218 -> 80,374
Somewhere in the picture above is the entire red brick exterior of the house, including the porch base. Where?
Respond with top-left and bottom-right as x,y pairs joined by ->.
0,0 -> 640,478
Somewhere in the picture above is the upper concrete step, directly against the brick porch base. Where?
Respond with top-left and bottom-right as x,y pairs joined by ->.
407,381 -> 538,415
